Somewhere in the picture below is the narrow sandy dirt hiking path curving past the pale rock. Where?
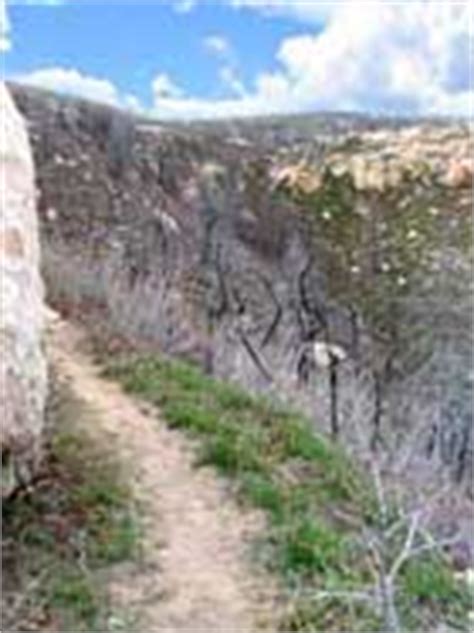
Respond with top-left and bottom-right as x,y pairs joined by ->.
50,321 -> 271,633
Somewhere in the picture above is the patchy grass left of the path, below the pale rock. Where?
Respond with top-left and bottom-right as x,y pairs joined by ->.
2,388 -> 140,631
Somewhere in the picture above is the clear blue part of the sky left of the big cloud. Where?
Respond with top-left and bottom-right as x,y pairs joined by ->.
6,2 -> 301,105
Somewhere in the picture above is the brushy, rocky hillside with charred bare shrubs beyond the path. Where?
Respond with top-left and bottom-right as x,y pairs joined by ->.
10,80 -> 472,494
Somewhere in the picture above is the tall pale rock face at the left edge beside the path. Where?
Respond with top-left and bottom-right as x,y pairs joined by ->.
0,84 -> 47,497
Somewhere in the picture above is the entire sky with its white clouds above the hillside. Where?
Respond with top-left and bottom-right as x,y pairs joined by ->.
0,0 -> 472,118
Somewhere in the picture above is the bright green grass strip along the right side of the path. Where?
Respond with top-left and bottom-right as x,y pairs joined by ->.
107,358 -> 470,632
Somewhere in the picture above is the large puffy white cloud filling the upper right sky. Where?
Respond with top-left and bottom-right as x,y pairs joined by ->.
233,0 -> 472,114
